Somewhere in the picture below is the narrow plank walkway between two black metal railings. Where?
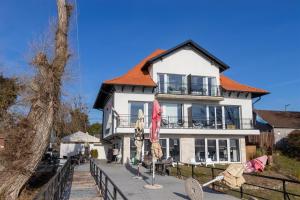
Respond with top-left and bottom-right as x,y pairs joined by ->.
69,163 -> 102,200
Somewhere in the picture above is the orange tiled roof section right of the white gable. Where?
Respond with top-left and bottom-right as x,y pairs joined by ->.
220,74 -> 269,94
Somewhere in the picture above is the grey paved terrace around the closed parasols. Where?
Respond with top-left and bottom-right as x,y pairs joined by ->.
96,160 -> 237,200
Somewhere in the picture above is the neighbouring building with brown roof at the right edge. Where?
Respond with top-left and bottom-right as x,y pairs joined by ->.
254,110 -> 300,146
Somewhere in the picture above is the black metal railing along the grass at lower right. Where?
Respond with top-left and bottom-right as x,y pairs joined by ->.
176,162 -> 300,200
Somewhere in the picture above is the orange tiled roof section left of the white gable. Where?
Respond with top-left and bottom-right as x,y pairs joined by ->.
104,49 -> 165,87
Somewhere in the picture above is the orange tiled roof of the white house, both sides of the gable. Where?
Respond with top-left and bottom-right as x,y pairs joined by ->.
104,49 -> 269,94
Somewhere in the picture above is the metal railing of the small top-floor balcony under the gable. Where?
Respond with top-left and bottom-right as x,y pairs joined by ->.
156,82 -> 221,96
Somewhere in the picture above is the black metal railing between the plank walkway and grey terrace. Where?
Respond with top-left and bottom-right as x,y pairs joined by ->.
90,159 -> 128,200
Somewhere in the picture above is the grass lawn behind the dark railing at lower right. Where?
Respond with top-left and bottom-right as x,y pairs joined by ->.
170,153 -> 300,200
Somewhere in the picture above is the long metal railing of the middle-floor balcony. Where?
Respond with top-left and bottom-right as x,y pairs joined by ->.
116,115 -> 253,129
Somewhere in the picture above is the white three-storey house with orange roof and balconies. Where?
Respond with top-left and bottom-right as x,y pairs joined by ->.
94,41 -> 268,163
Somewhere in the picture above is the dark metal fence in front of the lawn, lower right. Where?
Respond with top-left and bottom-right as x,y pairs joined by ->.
176,162 -> 300,200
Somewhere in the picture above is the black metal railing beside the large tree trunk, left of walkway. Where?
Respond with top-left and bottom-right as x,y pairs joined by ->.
33,159 -> 73,200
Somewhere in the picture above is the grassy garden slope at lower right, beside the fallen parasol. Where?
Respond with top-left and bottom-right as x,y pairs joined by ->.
170,152 -> 300,200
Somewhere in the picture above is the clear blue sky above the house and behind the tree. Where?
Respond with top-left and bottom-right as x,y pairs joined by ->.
0,0 -> 300,122
